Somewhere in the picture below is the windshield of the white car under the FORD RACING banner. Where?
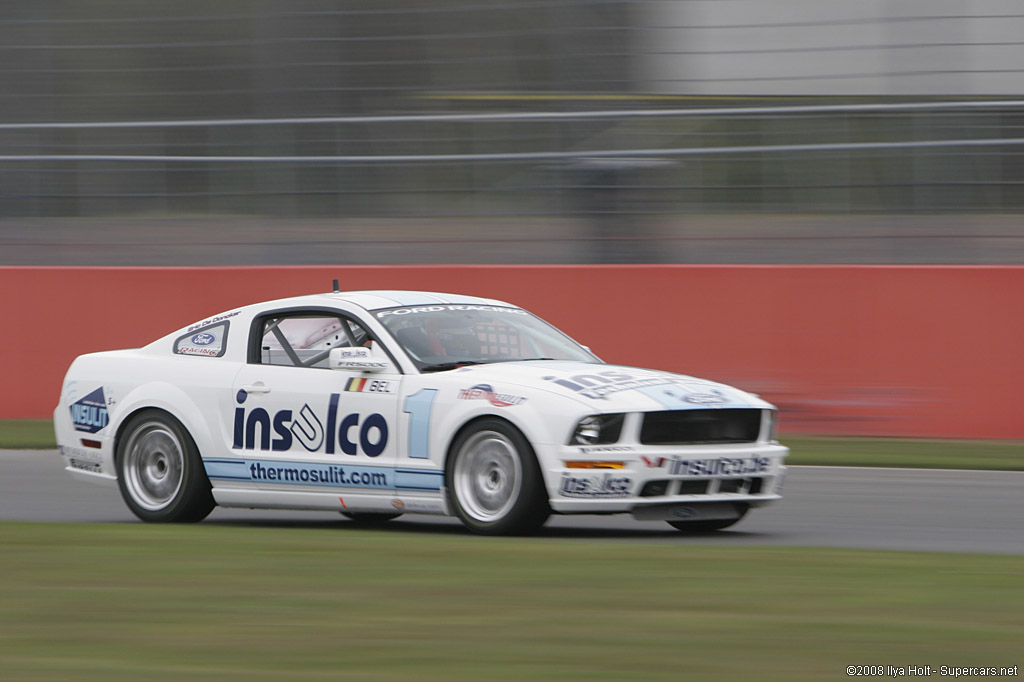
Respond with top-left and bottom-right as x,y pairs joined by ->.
375,304 -> 600,372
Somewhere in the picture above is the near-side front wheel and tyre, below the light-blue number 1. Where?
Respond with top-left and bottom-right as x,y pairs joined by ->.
444,418 -> 551,536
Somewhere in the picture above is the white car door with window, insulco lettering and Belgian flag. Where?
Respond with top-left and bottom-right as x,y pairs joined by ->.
226,310 -> 401,499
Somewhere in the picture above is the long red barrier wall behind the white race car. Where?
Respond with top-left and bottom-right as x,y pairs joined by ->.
0,265 -> 1024,438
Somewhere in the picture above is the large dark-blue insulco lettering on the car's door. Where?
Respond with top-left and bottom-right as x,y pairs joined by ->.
231,391 -> 389,457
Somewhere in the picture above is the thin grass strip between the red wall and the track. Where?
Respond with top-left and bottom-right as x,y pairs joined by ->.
9,420 -> 1024,471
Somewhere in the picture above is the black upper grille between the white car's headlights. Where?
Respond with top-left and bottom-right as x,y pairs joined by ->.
640,409 -> 761,445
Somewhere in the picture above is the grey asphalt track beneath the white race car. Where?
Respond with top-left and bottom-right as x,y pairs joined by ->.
0,451 -> 1024,554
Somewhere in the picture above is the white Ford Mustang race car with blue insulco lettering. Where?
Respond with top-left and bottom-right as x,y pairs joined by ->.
53,288 -> 788,535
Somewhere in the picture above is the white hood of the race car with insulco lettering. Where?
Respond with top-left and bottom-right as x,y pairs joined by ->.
453,360 -> 772,412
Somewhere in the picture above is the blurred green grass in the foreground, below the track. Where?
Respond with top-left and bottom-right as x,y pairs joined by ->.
0,523 -> 1024,682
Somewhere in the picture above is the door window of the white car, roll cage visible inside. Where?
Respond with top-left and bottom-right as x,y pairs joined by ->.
259,312 -> 372,369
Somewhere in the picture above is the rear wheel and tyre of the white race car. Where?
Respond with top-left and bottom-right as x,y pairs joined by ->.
115,410 -> 216,523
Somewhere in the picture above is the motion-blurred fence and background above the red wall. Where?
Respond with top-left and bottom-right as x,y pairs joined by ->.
0,0 -> 1024,265
